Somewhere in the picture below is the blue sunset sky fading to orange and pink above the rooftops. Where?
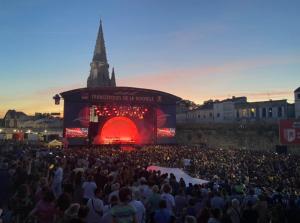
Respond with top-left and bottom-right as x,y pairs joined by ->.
0,0 -> 300,117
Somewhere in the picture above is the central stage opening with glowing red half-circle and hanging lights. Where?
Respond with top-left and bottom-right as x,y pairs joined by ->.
89,105 -> 156,145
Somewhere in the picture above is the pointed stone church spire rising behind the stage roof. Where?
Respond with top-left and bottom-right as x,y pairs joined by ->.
87,20 -> 116,88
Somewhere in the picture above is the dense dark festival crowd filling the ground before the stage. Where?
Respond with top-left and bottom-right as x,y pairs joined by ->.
0,142 -> 300,223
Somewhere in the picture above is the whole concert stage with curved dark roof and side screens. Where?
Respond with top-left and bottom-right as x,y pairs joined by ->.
60,87 -> 181,145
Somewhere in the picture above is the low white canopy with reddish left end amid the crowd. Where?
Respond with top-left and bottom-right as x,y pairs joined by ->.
147,166 -> 208,185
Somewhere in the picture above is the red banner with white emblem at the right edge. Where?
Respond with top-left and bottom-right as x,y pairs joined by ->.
279,120 -> 300,145
